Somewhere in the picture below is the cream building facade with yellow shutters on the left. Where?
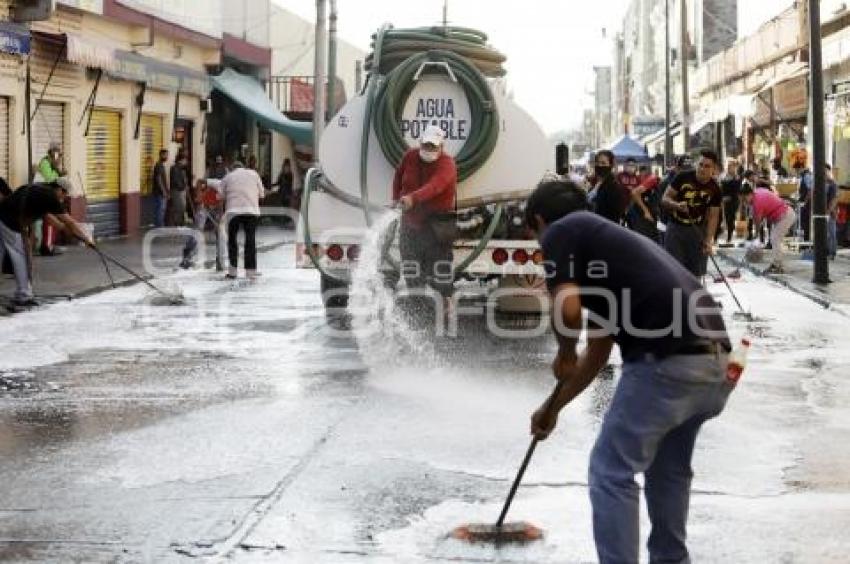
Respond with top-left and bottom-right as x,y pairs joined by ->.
0,0 -> 220,237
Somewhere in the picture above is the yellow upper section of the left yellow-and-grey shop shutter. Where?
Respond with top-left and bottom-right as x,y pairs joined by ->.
86,110 -> 121,203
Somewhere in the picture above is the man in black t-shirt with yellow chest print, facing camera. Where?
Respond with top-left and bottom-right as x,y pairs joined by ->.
661,151 -> 722,278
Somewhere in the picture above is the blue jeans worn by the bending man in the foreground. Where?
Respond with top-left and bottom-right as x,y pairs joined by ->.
589,354 -> 732,564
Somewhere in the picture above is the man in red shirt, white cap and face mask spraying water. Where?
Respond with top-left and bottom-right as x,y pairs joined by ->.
393,125 -> 457,297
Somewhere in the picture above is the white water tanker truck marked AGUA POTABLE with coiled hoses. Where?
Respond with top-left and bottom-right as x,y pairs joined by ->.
296,26 -> 551,315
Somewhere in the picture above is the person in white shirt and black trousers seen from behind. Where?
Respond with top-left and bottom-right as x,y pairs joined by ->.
221,162 -> 265,279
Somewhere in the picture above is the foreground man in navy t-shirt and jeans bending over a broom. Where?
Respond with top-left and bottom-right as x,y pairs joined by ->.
526,181 -> 732,564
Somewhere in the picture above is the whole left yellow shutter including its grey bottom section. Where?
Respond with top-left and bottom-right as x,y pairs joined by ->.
86,110 -> 121,237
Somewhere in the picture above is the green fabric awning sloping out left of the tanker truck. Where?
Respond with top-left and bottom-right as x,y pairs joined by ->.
211,68 -> 313,145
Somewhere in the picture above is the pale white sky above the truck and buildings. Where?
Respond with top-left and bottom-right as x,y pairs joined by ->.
275,0 -> 791,133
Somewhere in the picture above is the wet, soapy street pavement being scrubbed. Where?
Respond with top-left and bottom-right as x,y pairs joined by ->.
0,245 -> 850,563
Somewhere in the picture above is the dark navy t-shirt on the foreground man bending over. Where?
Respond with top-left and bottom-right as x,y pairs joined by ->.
543,212 -> 731,360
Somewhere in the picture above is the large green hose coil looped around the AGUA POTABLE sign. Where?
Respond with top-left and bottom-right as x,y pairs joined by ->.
370,51 -> 499,182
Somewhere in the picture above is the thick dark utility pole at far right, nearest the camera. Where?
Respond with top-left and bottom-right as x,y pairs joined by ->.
808,0 -> 830,284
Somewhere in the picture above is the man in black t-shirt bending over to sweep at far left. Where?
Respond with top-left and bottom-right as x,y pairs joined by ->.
0,183 -> 94,306
